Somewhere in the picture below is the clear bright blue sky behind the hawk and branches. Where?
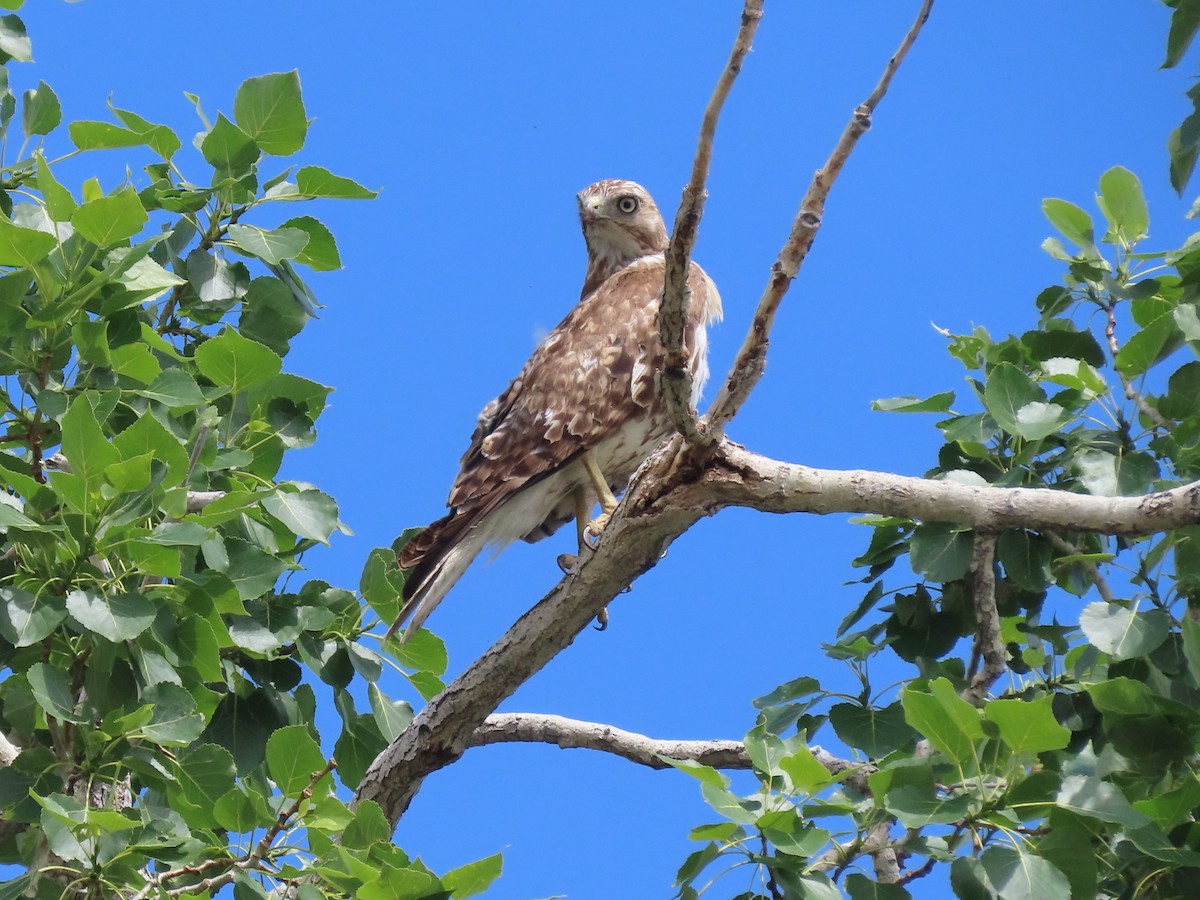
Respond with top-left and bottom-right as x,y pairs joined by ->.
21,0 -> 1190,900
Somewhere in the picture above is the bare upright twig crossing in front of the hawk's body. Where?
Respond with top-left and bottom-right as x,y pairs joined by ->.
659,0 -> 762,443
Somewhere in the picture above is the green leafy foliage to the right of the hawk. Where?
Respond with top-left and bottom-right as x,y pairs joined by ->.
678,168 -> 1200,900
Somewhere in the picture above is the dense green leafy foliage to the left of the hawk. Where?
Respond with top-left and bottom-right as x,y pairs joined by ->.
0,8 -> 499,900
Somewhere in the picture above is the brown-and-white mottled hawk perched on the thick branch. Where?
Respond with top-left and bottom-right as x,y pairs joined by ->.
389,180 -> 721,637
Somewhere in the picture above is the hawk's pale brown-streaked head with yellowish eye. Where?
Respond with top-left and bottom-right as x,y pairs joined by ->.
576,179 -> 667,296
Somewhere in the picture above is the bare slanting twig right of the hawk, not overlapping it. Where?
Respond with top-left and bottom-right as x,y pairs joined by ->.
706,0 -> 934,432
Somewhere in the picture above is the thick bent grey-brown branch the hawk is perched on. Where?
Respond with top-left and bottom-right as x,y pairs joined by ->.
359,438 -> 1200,822
